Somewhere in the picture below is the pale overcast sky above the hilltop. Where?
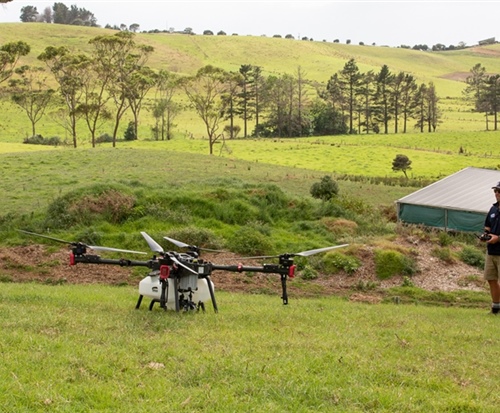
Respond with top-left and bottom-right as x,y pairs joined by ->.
0,0 -> 500,46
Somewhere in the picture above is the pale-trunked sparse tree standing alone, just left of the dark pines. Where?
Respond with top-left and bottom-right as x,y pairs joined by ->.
182,65 -> 228,155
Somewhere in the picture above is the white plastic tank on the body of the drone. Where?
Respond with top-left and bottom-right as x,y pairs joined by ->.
139,271 -> 214,310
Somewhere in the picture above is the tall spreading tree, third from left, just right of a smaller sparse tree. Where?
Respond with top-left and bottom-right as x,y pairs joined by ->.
38,46 -> 92,148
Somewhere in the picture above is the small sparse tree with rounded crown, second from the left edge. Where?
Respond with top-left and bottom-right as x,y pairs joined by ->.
9,66 -> 55,136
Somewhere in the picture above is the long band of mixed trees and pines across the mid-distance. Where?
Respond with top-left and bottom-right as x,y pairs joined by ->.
0,31 -> 440,153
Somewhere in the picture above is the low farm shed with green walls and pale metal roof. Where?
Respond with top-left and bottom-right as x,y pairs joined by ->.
396,167 -> 500,232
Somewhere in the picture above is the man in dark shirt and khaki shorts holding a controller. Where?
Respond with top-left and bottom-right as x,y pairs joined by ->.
481,182 -> 500,314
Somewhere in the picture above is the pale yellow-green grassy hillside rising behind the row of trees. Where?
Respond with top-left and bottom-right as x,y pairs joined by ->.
0,23 -> 500,142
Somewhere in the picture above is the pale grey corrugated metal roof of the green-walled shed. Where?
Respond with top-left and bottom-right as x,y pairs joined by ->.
396,167 -> 500,214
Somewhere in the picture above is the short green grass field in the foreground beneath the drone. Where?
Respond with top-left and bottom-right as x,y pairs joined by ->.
0,284 -> 500,413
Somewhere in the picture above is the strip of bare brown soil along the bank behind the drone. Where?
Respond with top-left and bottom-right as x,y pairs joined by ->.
0,238 -> 486,301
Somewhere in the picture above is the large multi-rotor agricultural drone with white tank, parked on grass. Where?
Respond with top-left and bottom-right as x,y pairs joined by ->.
19,230 -> 349,313
